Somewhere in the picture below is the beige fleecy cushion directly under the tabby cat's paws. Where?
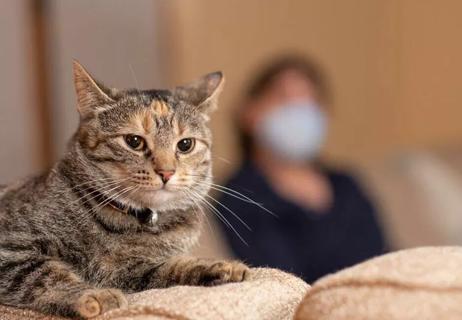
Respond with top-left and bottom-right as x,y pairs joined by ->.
0,268 -> 309,320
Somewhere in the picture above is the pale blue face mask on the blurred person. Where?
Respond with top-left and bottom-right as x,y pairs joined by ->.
256,102 -> 327,162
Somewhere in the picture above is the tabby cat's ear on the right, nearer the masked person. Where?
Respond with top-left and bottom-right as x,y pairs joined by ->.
174,71 -> 225,115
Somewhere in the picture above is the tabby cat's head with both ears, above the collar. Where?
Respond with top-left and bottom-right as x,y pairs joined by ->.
73,62 -> 224,216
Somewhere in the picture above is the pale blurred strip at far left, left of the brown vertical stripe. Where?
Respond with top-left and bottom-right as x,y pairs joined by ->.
0,0 -> 44,184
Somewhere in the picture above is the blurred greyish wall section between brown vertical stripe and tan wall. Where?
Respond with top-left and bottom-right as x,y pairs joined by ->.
46,0 -> 163,158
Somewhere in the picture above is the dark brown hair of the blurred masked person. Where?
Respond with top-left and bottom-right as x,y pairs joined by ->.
236,55 -> 331,158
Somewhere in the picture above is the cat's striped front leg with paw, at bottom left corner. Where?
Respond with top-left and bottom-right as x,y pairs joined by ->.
0,254 -> 127,318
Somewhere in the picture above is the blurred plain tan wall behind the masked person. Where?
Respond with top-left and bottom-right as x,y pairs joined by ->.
165,0 -> 462,180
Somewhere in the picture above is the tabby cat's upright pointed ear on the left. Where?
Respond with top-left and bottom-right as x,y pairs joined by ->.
73,60 -> 114,117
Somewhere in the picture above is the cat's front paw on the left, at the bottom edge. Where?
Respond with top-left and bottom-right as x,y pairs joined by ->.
75,289 -> 127,319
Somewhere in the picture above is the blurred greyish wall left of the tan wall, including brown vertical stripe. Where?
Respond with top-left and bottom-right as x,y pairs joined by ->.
0,0 -> 165,184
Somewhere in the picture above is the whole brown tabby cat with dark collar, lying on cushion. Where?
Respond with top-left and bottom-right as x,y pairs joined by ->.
0,61 -> 249,319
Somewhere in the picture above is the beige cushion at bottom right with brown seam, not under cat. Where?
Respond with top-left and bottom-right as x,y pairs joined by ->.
295,247 -> 462,320
